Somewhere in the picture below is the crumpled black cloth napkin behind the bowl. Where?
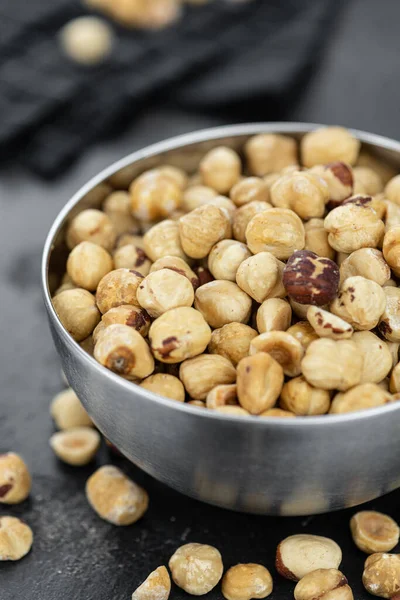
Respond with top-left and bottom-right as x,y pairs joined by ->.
0,0 -> 341,177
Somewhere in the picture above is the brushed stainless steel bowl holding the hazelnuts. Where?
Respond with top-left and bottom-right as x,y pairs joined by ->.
42,123 -> 400,515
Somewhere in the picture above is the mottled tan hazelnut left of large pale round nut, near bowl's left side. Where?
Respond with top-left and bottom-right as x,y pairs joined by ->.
95,269 -> 144,314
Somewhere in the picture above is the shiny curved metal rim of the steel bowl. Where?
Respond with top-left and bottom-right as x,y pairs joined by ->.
41,121 -> 400,428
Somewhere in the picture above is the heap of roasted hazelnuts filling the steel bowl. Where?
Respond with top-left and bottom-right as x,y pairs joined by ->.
53,127 -> 400,417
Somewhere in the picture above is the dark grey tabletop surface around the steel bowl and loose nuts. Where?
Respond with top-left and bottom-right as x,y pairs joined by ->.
0,0 -> 400,600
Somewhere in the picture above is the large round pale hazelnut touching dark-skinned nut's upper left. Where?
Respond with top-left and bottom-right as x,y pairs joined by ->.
246,208 -> 305,260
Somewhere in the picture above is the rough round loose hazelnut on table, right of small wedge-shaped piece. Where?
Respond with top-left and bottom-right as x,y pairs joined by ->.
168,543 -> 224,596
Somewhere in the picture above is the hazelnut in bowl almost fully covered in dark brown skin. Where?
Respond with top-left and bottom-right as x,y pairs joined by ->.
282,250 -> 340,306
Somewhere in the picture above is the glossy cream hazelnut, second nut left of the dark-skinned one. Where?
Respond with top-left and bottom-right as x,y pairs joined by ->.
208,240 -> 251,282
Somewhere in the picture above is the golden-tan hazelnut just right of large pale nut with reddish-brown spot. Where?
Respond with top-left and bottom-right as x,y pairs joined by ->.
208,322 -> 258,366
